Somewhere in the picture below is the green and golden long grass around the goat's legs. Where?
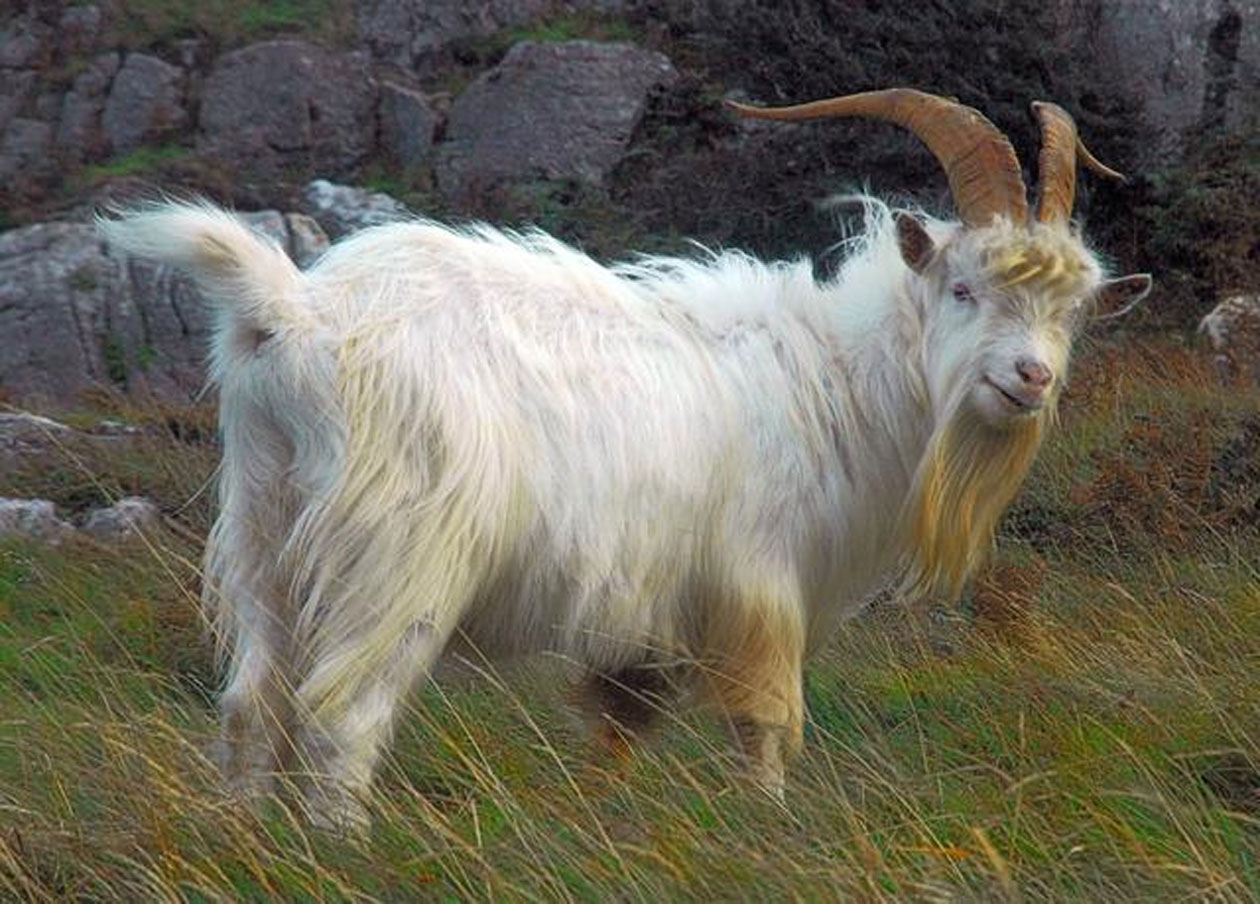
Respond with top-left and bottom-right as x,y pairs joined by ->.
0,340 -> 1260,901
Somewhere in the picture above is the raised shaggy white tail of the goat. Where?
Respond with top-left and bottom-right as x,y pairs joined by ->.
96,202 -> 309,347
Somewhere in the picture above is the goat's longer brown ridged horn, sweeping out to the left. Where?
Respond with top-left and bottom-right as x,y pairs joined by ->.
728,88 -> 1028,226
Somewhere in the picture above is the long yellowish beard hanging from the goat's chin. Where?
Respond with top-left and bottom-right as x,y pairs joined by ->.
902,410 -> 1052,599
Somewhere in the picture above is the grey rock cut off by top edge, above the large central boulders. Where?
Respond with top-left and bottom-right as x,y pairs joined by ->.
354,0 -> 626,74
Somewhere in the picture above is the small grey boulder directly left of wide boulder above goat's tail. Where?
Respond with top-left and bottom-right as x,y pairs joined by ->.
101,53 -> 188,154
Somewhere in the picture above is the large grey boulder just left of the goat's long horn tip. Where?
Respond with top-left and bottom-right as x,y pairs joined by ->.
437,40 -> 678,199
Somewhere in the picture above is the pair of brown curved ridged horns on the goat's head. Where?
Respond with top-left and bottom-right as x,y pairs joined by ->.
731,88 -> 1123,226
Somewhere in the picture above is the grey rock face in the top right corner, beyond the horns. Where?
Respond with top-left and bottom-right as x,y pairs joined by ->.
1055,0 -> 1260,166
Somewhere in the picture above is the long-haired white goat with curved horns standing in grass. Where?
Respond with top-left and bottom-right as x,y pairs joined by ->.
101,90 -> 1150,821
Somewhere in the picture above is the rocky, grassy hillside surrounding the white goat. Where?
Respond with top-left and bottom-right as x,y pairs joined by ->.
0,0 -> 1260,901
